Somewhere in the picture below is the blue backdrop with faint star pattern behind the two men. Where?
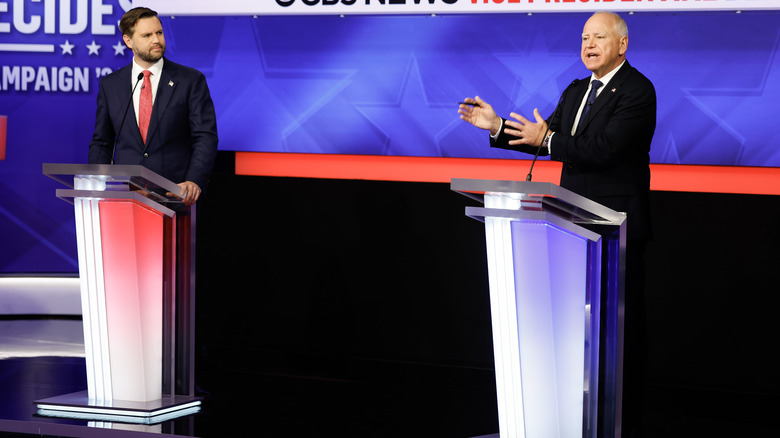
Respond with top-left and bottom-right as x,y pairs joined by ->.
0,3 -> 780,272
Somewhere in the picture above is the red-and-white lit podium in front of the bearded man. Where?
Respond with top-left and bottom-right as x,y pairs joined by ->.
35,163 -> 202,424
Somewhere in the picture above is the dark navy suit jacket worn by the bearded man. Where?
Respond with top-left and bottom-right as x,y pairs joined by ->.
89,59 -> 218,189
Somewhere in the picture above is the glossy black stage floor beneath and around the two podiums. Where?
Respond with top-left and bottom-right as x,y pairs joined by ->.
0,321 -> 780,438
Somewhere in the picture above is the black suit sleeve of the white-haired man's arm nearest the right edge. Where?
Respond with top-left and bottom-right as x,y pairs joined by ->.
551,77 -> 656,170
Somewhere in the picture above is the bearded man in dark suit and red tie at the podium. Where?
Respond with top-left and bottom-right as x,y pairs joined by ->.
89,8 -> 218,205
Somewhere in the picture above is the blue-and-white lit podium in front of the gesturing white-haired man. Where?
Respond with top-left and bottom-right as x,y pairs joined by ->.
451,179 -> 626,438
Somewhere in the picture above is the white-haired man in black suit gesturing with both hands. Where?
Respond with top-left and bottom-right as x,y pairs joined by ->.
458,12 -> 656,436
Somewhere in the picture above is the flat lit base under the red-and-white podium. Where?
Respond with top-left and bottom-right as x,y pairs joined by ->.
35,391 -> 203,424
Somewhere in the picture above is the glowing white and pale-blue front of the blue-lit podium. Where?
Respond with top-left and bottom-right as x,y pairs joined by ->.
484,194 -> 592,438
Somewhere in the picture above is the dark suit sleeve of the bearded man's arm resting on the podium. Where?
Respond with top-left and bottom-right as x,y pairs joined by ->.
185,72 -> 219,189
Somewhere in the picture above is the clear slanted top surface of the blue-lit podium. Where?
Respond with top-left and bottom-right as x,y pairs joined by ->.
450,178 -> 626,226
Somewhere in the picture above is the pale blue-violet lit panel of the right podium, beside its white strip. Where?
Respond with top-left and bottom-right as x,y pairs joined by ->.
512,220 -> 587,437
